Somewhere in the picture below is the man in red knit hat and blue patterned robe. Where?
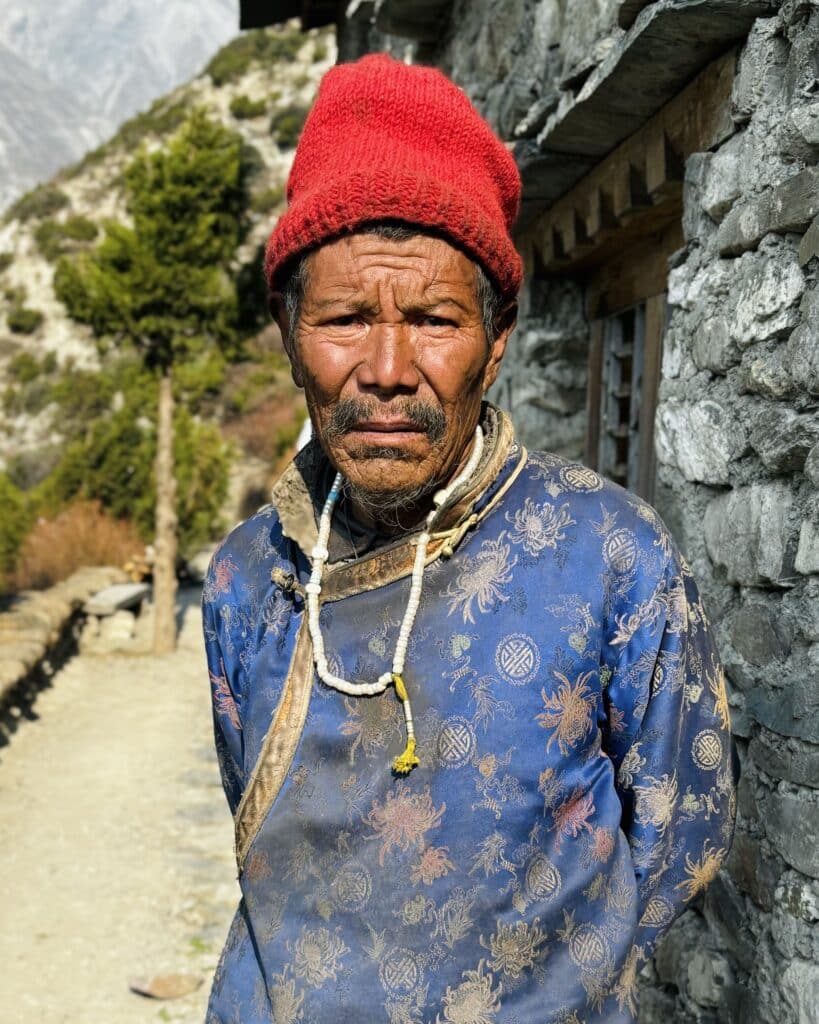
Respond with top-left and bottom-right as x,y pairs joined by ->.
204,56 -> 734,1024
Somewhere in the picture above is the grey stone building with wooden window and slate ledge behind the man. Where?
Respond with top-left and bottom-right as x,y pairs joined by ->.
243,0 -> 819,1024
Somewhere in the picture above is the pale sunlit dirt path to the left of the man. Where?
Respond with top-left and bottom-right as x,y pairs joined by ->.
0,593 -> 239,1024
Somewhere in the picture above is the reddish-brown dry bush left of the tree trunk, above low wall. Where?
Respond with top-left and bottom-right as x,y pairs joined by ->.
13,502 -> 144,590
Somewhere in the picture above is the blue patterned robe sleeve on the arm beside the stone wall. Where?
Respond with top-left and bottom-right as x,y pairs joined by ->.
604,535 -> 736,959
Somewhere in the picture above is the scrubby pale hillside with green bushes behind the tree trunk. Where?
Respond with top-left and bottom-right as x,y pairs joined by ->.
0,23 -> 335,590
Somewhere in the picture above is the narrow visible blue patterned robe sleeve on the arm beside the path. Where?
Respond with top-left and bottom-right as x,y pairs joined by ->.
202,553 -> 245,815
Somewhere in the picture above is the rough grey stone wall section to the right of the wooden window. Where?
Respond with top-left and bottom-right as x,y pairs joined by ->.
644,2 -> 819,1024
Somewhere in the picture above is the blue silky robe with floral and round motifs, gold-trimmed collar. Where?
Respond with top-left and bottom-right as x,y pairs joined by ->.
203,410 -> 735,1024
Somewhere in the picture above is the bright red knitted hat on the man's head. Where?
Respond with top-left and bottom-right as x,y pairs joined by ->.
264,53 -> 522,298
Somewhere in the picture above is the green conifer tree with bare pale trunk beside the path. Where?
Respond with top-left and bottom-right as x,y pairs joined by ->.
55,112 -> 244,653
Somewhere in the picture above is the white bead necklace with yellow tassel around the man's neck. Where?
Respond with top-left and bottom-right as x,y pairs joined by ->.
304,426 -> 483,775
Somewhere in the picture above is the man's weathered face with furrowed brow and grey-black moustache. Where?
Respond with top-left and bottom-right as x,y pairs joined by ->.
283,234 -> 511,516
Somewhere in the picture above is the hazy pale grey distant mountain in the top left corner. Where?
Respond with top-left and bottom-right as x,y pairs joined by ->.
0,0 -> 239,210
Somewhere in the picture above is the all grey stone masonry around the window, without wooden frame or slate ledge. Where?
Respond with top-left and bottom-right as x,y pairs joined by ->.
346,0 -> 819,1024
